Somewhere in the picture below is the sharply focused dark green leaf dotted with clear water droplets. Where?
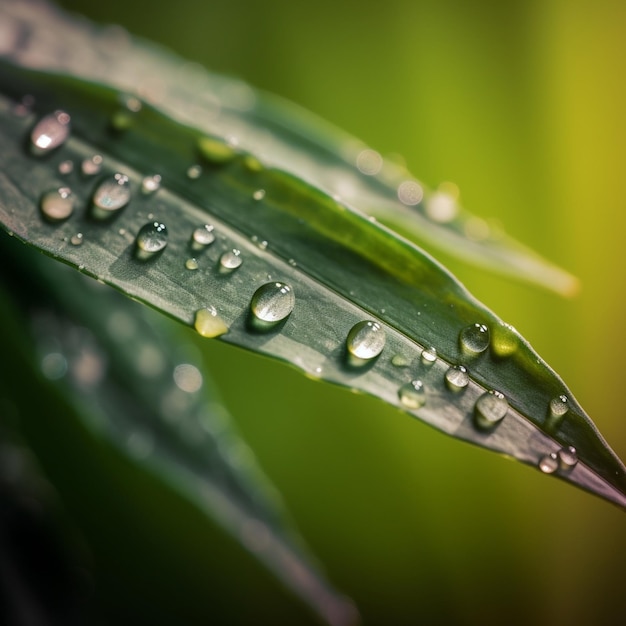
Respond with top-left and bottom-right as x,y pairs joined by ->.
3,0 -> 626,506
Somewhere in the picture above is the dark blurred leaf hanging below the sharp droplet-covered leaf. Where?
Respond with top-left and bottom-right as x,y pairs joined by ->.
0,238 -> 356,624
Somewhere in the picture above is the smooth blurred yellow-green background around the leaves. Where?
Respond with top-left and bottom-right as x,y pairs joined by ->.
47,0 -> 626,626
